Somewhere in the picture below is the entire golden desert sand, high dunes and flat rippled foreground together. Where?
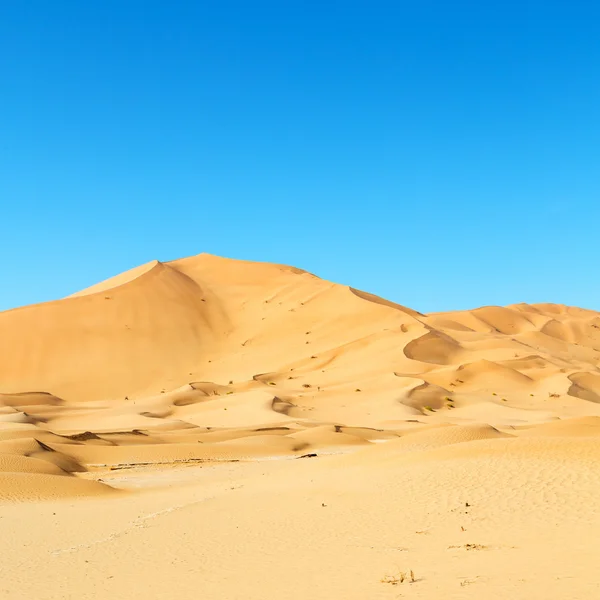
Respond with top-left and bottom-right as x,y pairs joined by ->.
0,254 -> 600,600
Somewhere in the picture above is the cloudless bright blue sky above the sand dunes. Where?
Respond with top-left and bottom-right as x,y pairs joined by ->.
0,0 -> 600,311
